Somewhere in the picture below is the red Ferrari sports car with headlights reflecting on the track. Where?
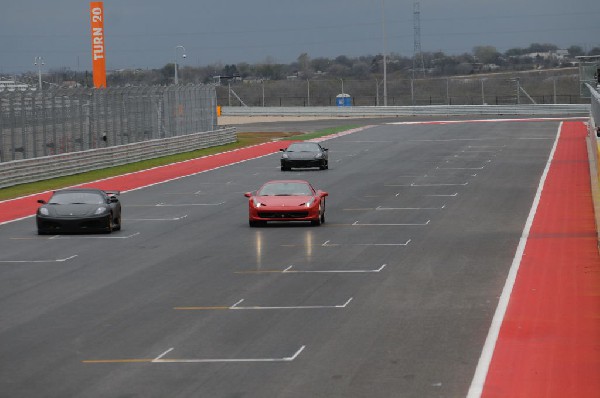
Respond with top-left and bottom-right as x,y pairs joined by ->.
244,180 -> 329,227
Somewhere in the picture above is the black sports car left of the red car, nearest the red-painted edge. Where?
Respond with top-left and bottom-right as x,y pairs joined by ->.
35,188 -> 121,235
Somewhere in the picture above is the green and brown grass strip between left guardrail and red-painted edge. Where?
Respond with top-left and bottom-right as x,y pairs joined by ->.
0,126 -> 357,200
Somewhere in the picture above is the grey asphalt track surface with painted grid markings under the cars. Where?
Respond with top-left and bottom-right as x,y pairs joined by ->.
0,116 -> 596,397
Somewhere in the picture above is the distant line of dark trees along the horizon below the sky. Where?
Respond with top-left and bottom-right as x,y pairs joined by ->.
5,43 -> 600,87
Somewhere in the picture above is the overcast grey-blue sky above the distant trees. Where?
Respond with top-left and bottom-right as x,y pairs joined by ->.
0,0 -> 600,73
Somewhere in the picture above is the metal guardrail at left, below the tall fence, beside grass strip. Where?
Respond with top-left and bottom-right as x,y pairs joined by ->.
0,127 -> 236,188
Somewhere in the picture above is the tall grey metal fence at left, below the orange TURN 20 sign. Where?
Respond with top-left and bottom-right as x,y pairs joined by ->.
0,85 -> 217,162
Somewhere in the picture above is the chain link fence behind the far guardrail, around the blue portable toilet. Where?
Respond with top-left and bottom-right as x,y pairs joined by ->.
217,73 -> 588,107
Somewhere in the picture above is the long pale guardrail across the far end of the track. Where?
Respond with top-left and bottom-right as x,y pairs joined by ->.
221,104 -> 590,117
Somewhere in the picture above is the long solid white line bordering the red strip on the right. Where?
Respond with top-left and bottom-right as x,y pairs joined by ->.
467,122 -> 563,398
